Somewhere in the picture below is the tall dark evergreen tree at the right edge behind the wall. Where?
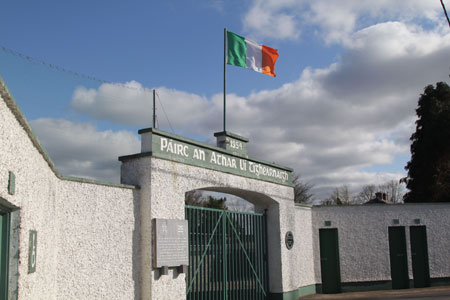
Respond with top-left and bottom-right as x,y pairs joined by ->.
402,82 -> 450,202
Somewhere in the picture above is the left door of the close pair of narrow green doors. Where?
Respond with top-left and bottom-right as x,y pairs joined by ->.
389,226 -> 409,289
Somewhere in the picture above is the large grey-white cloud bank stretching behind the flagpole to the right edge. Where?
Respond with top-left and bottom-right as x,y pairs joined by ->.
55,19 -> 450,198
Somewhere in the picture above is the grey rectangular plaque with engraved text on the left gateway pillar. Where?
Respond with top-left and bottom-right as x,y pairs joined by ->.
153,219 -> 189,268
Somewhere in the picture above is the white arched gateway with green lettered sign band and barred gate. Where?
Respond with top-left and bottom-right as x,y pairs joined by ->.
119,128 -> 294,300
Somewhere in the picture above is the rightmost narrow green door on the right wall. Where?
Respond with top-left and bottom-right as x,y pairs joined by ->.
409,226 -> 430,288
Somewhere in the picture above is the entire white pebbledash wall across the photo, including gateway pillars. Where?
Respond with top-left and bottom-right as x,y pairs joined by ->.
0,80 -> 450,300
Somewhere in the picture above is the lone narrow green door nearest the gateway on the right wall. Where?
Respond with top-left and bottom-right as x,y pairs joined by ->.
319,228 -> 341,294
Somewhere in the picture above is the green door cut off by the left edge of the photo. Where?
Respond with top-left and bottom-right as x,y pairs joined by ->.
0,212 -> 9,300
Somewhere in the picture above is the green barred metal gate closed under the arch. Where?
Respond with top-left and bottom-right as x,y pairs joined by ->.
186,206 -> 268,300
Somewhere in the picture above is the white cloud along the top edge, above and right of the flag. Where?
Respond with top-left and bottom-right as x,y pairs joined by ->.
243,0 -> 442,43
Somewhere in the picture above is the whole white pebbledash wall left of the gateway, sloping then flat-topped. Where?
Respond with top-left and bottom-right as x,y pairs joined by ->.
0,80 -> 139,300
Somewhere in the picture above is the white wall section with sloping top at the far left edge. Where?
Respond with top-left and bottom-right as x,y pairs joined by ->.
0,90 -> 57,300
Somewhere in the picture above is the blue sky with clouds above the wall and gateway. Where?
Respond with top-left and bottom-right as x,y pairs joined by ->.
0,0 -> 450,199
